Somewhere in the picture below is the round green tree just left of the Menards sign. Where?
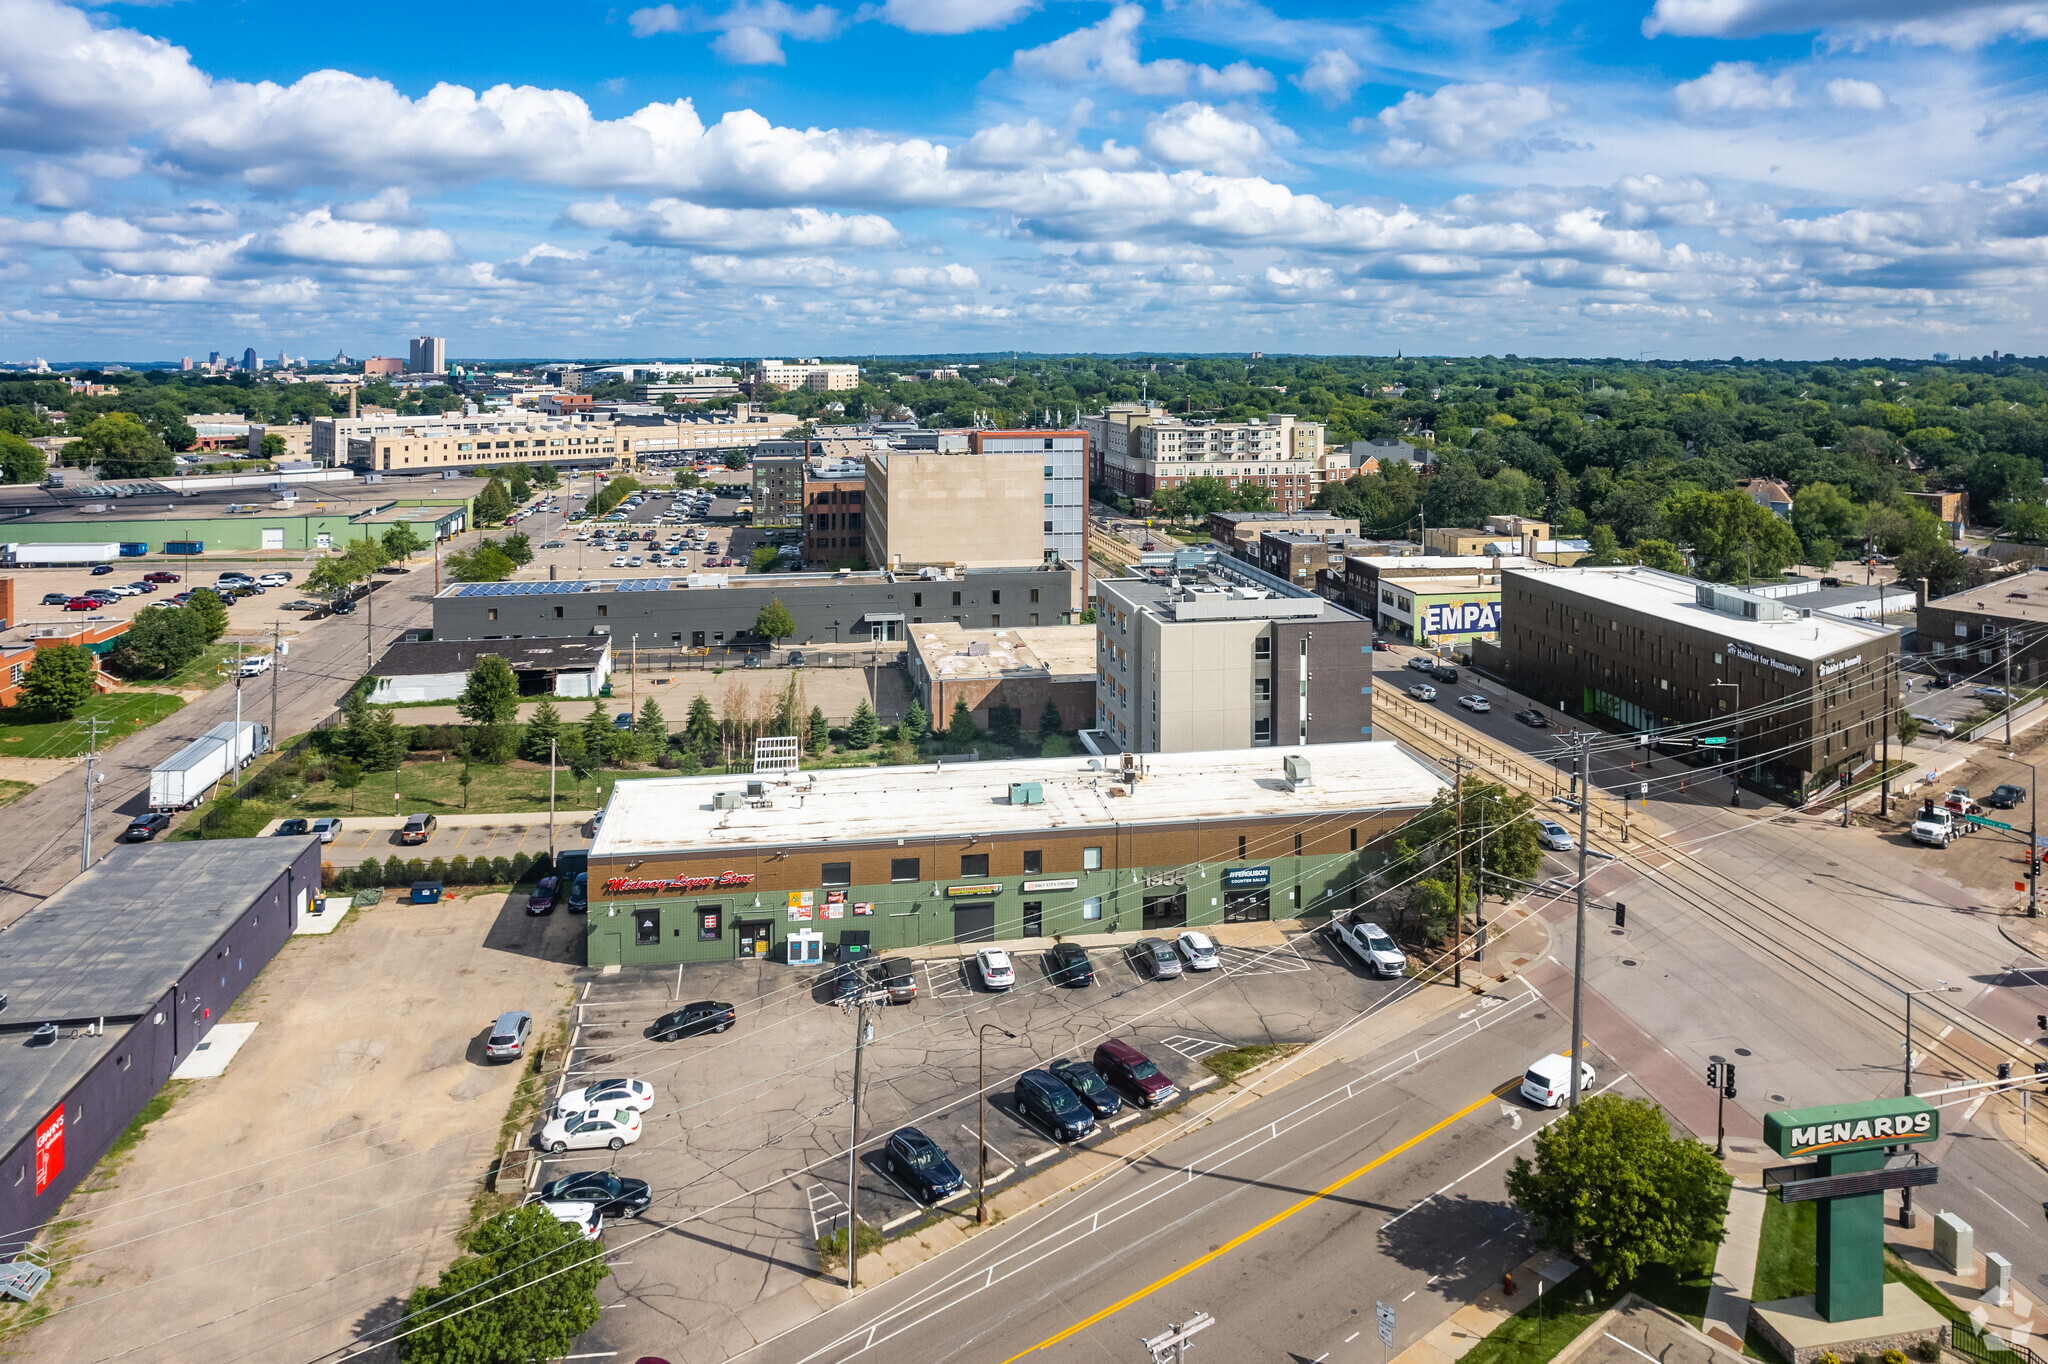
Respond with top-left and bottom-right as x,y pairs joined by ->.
1507,1094 -> 1729,1288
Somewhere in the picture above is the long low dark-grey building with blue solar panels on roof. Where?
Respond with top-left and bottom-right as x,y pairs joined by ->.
434,563 -> 1073,649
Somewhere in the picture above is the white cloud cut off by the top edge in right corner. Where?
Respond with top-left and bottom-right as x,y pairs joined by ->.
1642,0 -> 2048,47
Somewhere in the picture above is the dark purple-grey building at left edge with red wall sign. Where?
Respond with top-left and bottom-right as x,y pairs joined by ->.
0,836 -> 319,1258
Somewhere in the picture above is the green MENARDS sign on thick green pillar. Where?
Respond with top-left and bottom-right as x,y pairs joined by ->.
1763,1098 -> 1942,1321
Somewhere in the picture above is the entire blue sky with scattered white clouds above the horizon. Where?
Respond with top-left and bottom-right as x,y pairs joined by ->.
0,0 -> 2048,360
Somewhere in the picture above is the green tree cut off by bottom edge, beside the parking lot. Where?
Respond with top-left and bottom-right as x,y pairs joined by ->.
399,1202 -> 610,1364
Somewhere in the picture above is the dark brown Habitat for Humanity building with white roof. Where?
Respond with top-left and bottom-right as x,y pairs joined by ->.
1475,567 -> 1898,795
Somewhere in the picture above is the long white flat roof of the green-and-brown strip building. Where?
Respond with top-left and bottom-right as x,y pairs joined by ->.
590,739 -> 1446,858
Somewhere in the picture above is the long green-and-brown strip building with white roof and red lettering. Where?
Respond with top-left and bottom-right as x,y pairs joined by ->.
586,743 -> 1444,967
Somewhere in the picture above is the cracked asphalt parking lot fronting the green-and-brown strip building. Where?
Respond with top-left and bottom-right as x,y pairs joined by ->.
545,934 -> 1433,1358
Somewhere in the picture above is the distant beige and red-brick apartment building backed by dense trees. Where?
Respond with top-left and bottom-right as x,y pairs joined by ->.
1102,412 -> 1325,512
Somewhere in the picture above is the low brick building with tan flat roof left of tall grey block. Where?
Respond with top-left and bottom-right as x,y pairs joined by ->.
907,621 -> 1096,733
